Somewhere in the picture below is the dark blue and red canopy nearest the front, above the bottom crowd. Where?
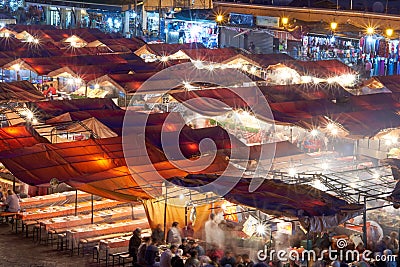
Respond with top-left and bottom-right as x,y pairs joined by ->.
172,175 -> 363,229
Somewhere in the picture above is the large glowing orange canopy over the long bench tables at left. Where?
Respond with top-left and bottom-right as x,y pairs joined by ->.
0,137 -> 228,201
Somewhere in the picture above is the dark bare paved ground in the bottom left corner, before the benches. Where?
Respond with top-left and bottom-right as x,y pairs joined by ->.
0,223 -> 105,267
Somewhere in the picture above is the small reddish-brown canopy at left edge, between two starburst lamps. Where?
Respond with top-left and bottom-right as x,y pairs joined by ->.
0,81 -> 44,102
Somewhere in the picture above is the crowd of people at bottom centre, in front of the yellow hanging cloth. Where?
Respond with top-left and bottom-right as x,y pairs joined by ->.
129,222 -> 254,267
